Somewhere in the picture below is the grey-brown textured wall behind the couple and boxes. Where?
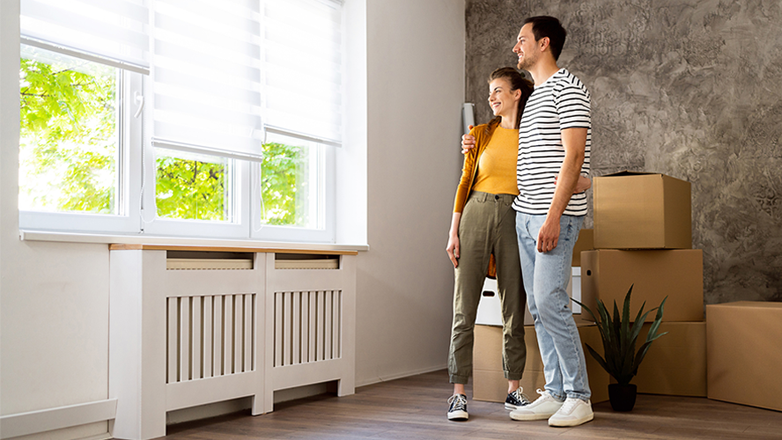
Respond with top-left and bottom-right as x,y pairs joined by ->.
466,0 -> 782,303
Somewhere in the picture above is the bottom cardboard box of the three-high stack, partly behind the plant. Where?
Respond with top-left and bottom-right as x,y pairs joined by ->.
632,322 -> 706,397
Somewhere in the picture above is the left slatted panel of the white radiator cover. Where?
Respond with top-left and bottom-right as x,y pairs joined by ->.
166,293 -> 257,384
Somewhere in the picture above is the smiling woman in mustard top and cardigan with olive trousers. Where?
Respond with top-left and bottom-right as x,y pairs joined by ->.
446,67 -> 591,420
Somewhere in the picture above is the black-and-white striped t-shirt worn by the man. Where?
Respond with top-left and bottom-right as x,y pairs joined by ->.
513,69 -> 592,216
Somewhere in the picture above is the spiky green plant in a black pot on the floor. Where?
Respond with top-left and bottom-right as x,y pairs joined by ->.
573,286 -> 668,411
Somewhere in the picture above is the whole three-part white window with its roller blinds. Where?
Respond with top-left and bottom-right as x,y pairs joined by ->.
19,0 -> 343,242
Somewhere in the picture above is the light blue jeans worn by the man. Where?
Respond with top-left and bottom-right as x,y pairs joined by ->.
516,212 -> 592,400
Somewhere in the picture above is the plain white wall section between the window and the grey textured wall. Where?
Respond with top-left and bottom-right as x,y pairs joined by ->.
356,0 -> 465,385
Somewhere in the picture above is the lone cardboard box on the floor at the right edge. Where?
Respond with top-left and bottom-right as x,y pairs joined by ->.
706,301 -> 782,411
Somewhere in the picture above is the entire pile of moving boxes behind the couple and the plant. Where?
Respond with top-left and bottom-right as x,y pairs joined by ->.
473,172 -> 782,411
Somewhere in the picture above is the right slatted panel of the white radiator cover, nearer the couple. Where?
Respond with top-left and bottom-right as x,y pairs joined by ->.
272,290 -> 343,367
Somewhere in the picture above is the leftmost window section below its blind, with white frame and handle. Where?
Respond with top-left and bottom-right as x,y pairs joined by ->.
19,44 -> 141,233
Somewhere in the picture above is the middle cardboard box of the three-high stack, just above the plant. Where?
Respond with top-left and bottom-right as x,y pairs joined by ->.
581,249 -> 703,322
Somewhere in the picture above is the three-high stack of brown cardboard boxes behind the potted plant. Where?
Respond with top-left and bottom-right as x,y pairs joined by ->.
581,172 -> 706,397
